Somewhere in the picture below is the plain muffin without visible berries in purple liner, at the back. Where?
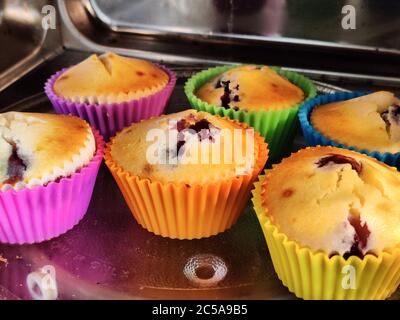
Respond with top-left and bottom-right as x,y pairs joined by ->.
45,53 -> 176,140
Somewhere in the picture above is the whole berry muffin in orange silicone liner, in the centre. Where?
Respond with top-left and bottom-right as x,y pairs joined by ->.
105,110 -> 268,239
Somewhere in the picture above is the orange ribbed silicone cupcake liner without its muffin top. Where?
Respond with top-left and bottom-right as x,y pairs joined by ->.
105,120 -> 268,239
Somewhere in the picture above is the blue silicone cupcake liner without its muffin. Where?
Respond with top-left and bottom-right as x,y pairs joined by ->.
299,91 -> 400,169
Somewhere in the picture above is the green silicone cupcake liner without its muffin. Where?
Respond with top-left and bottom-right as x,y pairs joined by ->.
185,66 -> 317,160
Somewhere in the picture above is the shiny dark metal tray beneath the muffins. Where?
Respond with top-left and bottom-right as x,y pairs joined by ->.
0,51 -> 400,299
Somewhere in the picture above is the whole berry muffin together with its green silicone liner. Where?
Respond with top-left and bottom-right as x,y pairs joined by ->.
185,65 -> 316,159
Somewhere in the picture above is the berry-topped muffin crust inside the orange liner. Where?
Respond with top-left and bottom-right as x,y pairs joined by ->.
110,110 -> 267,184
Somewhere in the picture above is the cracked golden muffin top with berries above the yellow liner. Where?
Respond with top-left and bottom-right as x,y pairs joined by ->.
261,147 -> 400,258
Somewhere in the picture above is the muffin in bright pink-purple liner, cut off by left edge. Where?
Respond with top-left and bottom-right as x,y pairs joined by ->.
0,112 -> 104,244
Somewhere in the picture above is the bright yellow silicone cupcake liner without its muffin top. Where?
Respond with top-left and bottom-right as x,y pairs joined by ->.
252,176 -> 400,300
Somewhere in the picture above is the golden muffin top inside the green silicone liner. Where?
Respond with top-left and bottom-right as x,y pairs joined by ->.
195,66 -> 304,111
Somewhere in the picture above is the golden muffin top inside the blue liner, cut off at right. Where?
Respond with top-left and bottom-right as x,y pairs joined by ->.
310,91 -> 400,153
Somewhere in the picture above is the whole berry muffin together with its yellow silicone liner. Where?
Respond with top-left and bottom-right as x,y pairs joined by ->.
253,147 -> 400,299
